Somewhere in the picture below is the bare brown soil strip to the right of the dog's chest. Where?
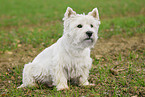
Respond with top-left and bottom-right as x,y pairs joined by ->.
92,33 -> 145,57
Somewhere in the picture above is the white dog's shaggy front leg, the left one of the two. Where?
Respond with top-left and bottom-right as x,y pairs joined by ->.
54,68 -> 69,91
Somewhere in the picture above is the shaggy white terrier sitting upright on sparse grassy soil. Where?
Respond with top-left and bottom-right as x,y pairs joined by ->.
18,7 -> 100,90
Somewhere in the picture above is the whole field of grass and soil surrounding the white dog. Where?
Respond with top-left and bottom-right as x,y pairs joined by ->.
0,0 -> 145,97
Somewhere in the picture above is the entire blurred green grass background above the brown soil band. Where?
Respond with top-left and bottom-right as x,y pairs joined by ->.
0,0 -> 145,51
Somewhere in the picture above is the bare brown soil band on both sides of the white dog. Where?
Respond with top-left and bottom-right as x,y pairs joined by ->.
0,33 -> 145,71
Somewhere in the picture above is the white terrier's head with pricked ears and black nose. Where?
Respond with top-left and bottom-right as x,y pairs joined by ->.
63,7 -> 100,48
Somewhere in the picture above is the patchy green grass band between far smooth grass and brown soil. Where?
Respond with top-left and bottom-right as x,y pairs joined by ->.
0,15 -> 145,51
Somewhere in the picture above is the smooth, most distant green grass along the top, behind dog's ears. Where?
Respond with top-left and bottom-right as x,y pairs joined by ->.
0,0 -> 145,26
